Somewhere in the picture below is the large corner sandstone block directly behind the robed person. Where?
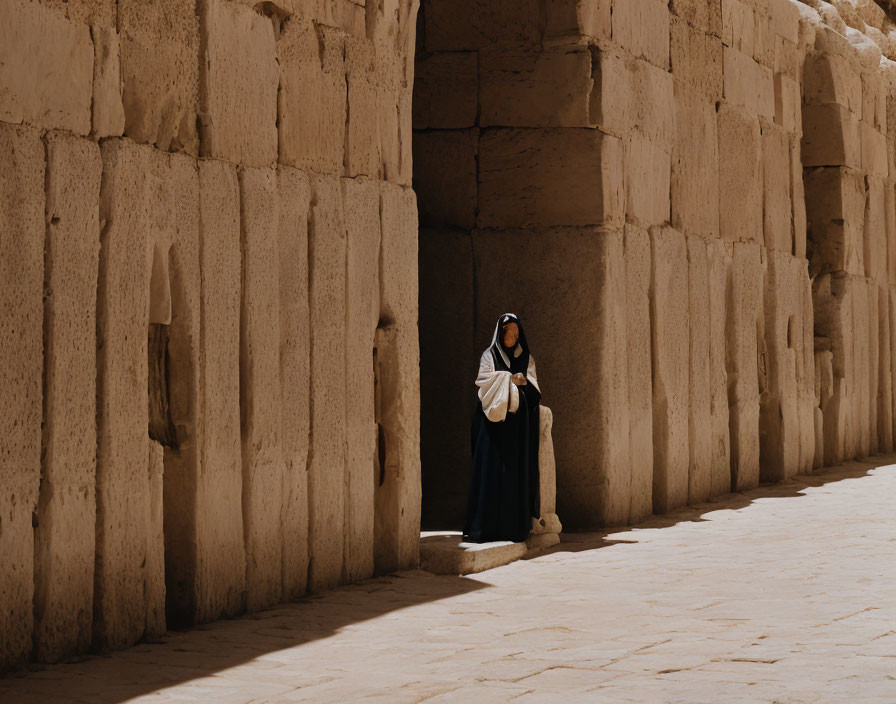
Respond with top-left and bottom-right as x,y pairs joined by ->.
476,228 -> 631,528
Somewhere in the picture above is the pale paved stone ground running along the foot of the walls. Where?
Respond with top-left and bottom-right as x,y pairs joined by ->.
0,457 -> 896,704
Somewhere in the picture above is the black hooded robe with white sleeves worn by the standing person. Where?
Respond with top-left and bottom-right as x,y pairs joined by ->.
464,313 -> 541,543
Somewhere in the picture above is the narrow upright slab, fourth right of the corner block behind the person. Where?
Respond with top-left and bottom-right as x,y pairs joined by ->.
706,239 -> 731,496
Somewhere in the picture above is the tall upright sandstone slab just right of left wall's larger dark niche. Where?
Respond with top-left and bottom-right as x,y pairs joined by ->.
195,159 -> 246,622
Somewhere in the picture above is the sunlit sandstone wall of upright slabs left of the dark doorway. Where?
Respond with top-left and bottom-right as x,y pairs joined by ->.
0,0 -> 419,667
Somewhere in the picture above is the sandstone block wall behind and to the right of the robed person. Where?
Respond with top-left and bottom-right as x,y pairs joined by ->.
414,0 -> 896,529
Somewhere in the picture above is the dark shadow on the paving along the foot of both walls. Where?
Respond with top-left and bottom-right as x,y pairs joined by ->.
0,456 -> 896,704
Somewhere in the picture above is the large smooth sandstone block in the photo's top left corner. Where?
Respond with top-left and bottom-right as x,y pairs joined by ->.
0,0 -> 93,135
